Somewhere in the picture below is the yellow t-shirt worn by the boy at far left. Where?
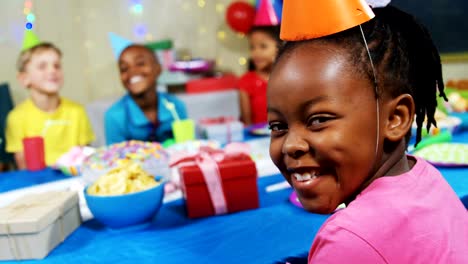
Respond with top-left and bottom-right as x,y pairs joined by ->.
5,98 -> 94,166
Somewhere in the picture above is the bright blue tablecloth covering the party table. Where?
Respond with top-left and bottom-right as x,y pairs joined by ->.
0,132 -> 468,263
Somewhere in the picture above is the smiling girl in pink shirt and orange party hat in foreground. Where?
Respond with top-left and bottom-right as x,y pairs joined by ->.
267,0 -> 468,263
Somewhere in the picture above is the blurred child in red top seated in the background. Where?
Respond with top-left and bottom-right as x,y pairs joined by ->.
238,26 -> 281,125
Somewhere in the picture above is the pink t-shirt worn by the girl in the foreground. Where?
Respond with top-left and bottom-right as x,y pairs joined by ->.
309,158 -> 468,264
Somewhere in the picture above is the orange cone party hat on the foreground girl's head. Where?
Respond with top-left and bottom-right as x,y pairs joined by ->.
280,0 -> 375,41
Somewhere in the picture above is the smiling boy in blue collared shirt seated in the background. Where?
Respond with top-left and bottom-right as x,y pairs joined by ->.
105,44 -> 187,144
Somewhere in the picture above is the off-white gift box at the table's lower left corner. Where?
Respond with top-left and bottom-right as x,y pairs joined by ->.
0,191 -> 81,260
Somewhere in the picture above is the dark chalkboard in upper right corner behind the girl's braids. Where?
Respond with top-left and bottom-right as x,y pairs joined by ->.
391,0 -> 468,59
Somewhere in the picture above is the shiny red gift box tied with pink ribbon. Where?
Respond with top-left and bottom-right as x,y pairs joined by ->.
179,145 -> 259,218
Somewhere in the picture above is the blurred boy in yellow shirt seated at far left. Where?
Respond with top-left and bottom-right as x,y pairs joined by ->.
6,43 -> 94,169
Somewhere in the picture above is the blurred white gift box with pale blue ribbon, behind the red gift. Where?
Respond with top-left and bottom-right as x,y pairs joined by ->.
197,117 -> 244,144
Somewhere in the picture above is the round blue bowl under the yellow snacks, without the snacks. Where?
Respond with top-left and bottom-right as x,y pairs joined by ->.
84,182 -> 164,229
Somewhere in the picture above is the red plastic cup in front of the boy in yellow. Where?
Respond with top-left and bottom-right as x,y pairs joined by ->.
23,137 -> 46,171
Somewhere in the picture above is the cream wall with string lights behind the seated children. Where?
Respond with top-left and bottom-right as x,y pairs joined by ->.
0,0 -> 468,106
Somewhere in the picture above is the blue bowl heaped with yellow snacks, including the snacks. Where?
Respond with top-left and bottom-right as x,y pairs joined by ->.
84,160 -> 165,229
